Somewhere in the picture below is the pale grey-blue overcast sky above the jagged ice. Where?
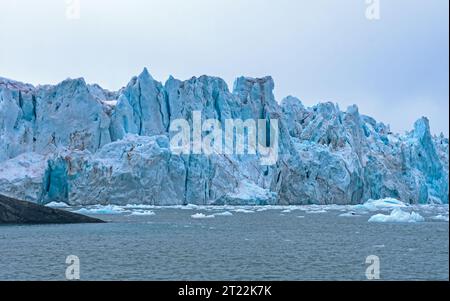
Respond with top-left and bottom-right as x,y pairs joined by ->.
0,0 -> 449,136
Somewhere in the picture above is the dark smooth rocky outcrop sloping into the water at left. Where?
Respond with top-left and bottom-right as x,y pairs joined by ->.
0,195 -> 104,225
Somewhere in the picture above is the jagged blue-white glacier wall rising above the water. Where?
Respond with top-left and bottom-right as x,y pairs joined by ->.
0,69 -> 449,207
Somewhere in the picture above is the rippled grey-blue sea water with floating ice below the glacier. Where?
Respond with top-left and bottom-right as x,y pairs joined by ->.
0,206 -> 449,280
